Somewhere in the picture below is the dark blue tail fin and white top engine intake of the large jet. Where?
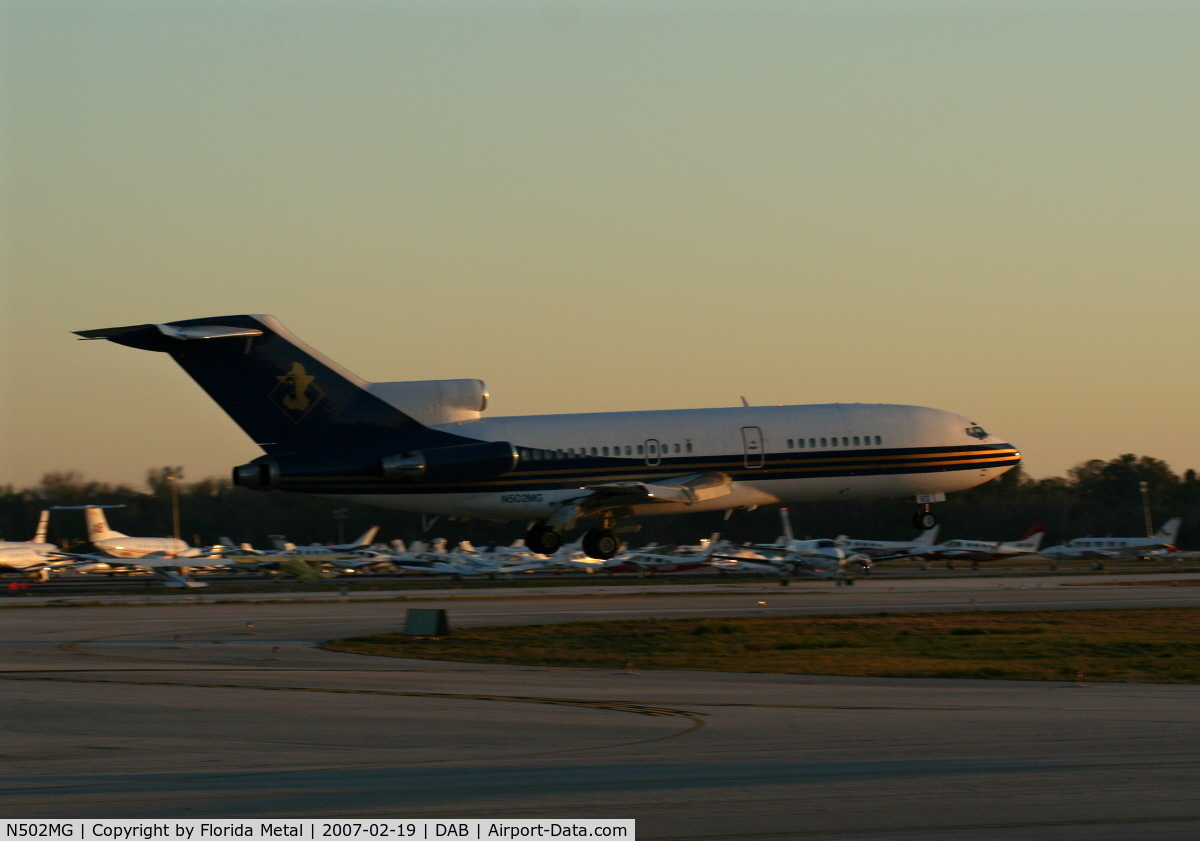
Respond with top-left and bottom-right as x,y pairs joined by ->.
77,316 -> 487,452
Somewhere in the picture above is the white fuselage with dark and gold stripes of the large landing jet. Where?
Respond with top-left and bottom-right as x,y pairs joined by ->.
330,403 -> 1020,519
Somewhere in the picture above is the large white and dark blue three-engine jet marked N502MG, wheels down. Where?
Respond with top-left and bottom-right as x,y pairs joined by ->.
78,316 -> 1020,559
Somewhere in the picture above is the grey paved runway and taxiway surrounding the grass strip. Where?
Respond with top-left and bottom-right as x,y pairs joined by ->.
0,575 -> 1200,841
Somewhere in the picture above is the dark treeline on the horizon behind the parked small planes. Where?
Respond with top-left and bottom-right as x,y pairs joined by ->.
0,455 -> 1200,548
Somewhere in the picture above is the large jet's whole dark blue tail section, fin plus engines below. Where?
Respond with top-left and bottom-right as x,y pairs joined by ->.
77,316 -> 520,491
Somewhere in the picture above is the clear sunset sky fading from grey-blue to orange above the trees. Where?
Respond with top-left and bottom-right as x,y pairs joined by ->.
0,0 -> 1200,485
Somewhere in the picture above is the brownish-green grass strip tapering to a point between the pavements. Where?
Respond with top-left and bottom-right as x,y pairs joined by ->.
324,607 -> 1200,684
